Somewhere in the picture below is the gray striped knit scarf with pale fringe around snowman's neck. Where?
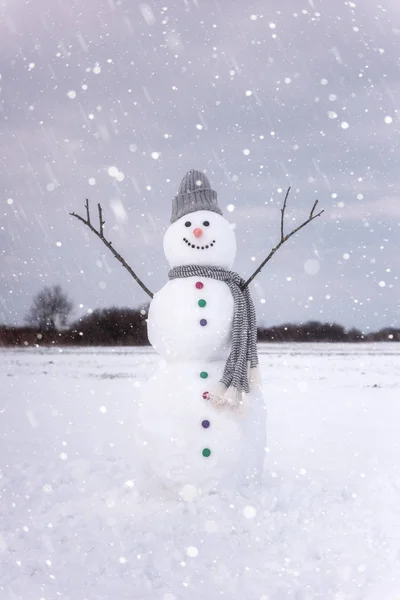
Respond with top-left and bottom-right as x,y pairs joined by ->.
168,265 -> 258,409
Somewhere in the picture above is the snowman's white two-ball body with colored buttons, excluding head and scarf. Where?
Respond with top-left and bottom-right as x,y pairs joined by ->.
137,277 -> 265,490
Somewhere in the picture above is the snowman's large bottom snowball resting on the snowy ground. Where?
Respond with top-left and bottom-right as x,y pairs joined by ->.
135,360 -> 266,492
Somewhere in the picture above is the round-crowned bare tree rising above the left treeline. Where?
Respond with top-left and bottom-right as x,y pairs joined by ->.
25,285 -> 73,331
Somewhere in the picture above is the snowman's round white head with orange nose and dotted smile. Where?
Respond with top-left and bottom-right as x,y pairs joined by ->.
164,210 -> 236,269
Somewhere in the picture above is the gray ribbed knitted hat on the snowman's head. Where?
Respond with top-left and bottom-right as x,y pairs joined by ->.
171,169 -> 222,223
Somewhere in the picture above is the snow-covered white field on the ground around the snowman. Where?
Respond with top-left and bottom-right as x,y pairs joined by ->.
0,344 -> 400,600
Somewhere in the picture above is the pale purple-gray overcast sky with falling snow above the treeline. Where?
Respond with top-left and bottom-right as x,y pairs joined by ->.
0,0 -> 400,330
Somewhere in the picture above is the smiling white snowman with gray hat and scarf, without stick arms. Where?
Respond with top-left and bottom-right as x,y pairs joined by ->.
135,170 -> 266,494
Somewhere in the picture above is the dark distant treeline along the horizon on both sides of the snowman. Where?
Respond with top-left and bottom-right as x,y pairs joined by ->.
0,307 -> 400,346
